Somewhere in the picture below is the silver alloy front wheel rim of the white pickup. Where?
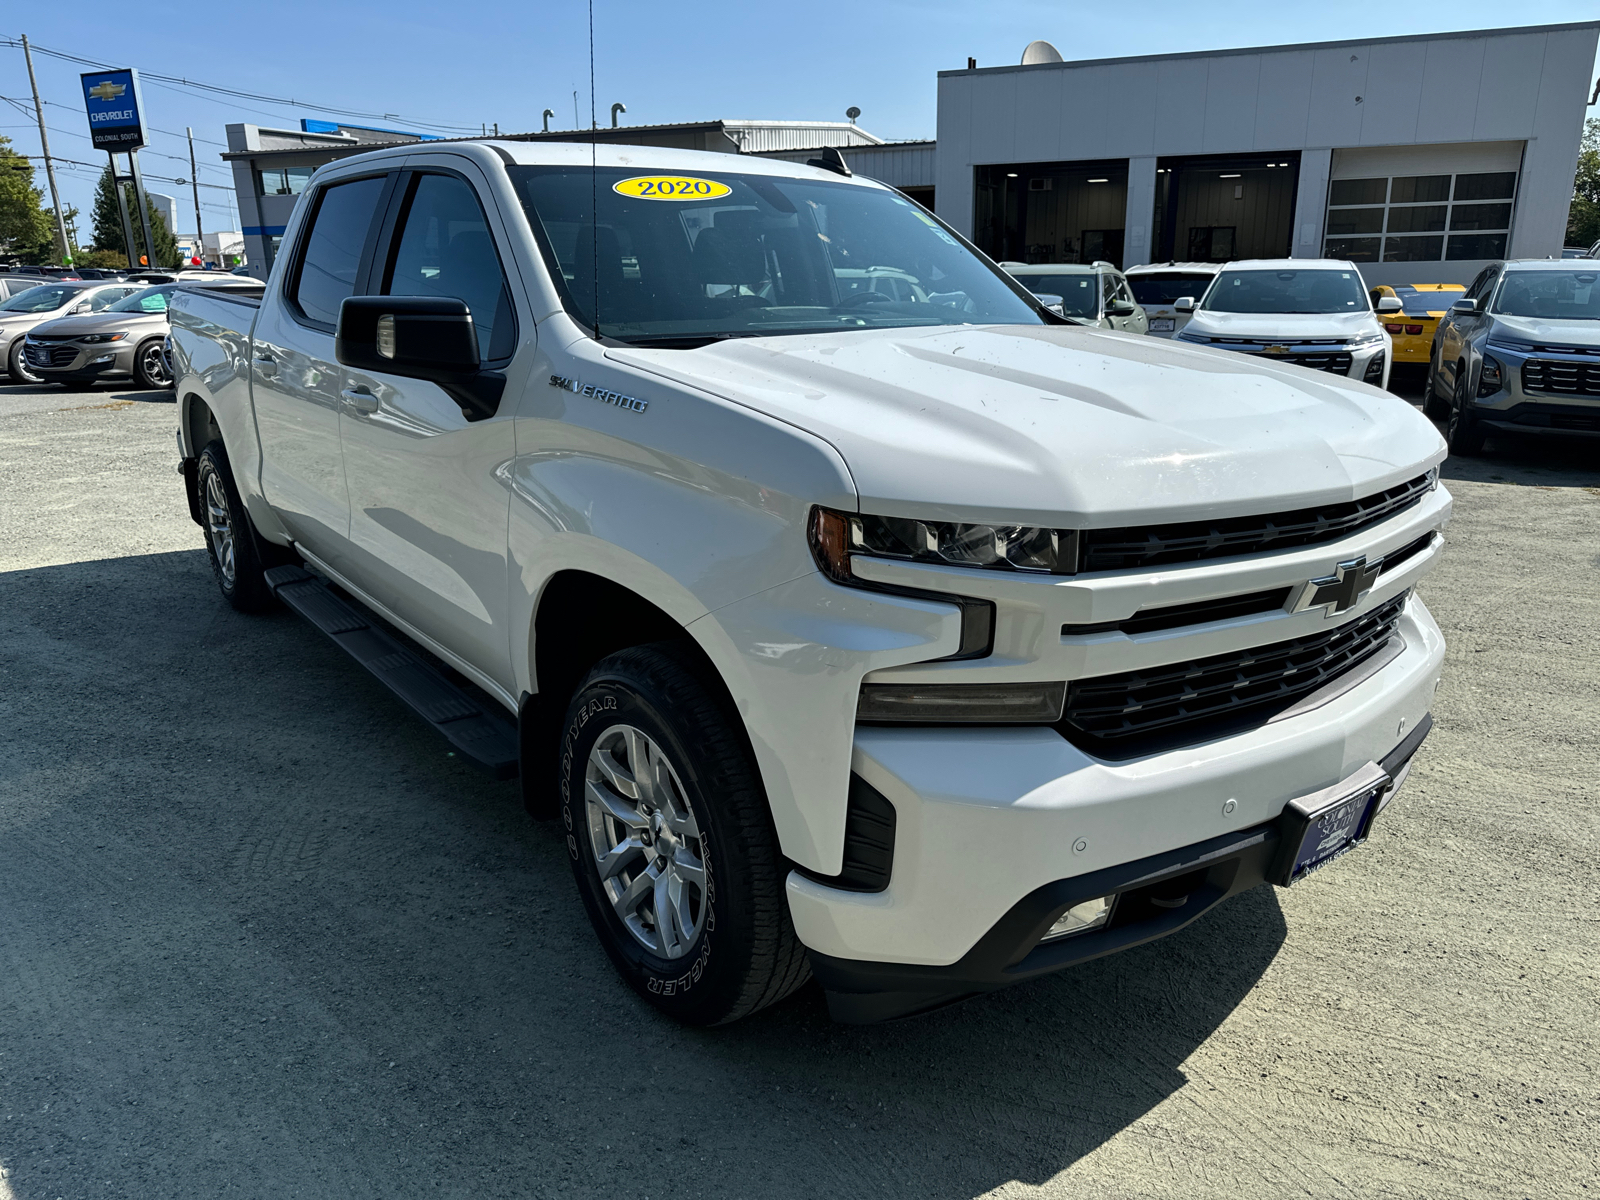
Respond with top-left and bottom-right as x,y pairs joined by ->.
584,725 -> 710,958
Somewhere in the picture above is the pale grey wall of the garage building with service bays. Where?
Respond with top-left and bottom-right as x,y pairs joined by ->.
936,22 -> 1600,278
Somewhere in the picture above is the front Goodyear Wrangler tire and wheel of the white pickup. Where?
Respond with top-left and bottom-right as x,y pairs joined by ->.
560,642 -> 810,1026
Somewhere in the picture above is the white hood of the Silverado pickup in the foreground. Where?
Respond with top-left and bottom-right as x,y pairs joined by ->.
606,326 -> 1445,528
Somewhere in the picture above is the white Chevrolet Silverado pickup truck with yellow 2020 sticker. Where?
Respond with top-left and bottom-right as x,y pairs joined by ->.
171,141 -> 1451,1024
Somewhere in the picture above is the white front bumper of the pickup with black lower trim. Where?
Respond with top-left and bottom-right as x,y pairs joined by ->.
787,597 -> 1445,1019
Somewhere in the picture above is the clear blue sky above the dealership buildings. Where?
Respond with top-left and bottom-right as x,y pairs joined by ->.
9,0 -> 1597,240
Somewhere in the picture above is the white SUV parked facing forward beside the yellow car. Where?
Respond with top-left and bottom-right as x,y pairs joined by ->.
1173,258 -> 1400,387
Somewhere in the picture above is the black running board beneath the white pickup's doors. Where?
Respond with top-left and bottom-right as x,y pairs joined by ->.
266,566 -> 517,779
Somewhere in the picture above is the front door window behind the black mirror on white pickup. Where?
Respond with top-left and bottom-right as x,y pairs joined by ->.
382,174 -> 517,360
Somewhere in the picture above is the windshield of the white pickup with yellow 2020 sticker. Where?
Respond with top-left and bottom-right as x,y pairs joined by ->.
509,166 -> 1045,347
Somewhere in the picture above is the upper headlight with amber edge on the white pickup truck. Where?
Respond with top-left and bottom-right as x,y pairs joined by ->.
811,509 -> 1078,582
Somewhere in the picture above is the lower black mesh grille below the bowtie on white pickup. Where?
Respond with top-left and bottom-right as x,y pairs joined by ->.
1056,592 -> 1410,758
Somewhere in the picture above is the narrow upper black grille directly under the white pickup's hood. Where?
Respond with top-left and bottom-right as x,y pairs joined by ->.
1078,472 -> 1434,571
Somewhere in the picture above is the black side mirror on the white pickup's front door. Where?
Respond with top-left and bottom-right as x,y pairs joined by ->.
333,296 -> 506,421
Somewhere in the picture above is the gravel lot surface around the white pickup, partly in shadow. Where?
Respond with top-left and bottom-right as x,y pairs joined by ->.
0,371 -> 1600,1200
